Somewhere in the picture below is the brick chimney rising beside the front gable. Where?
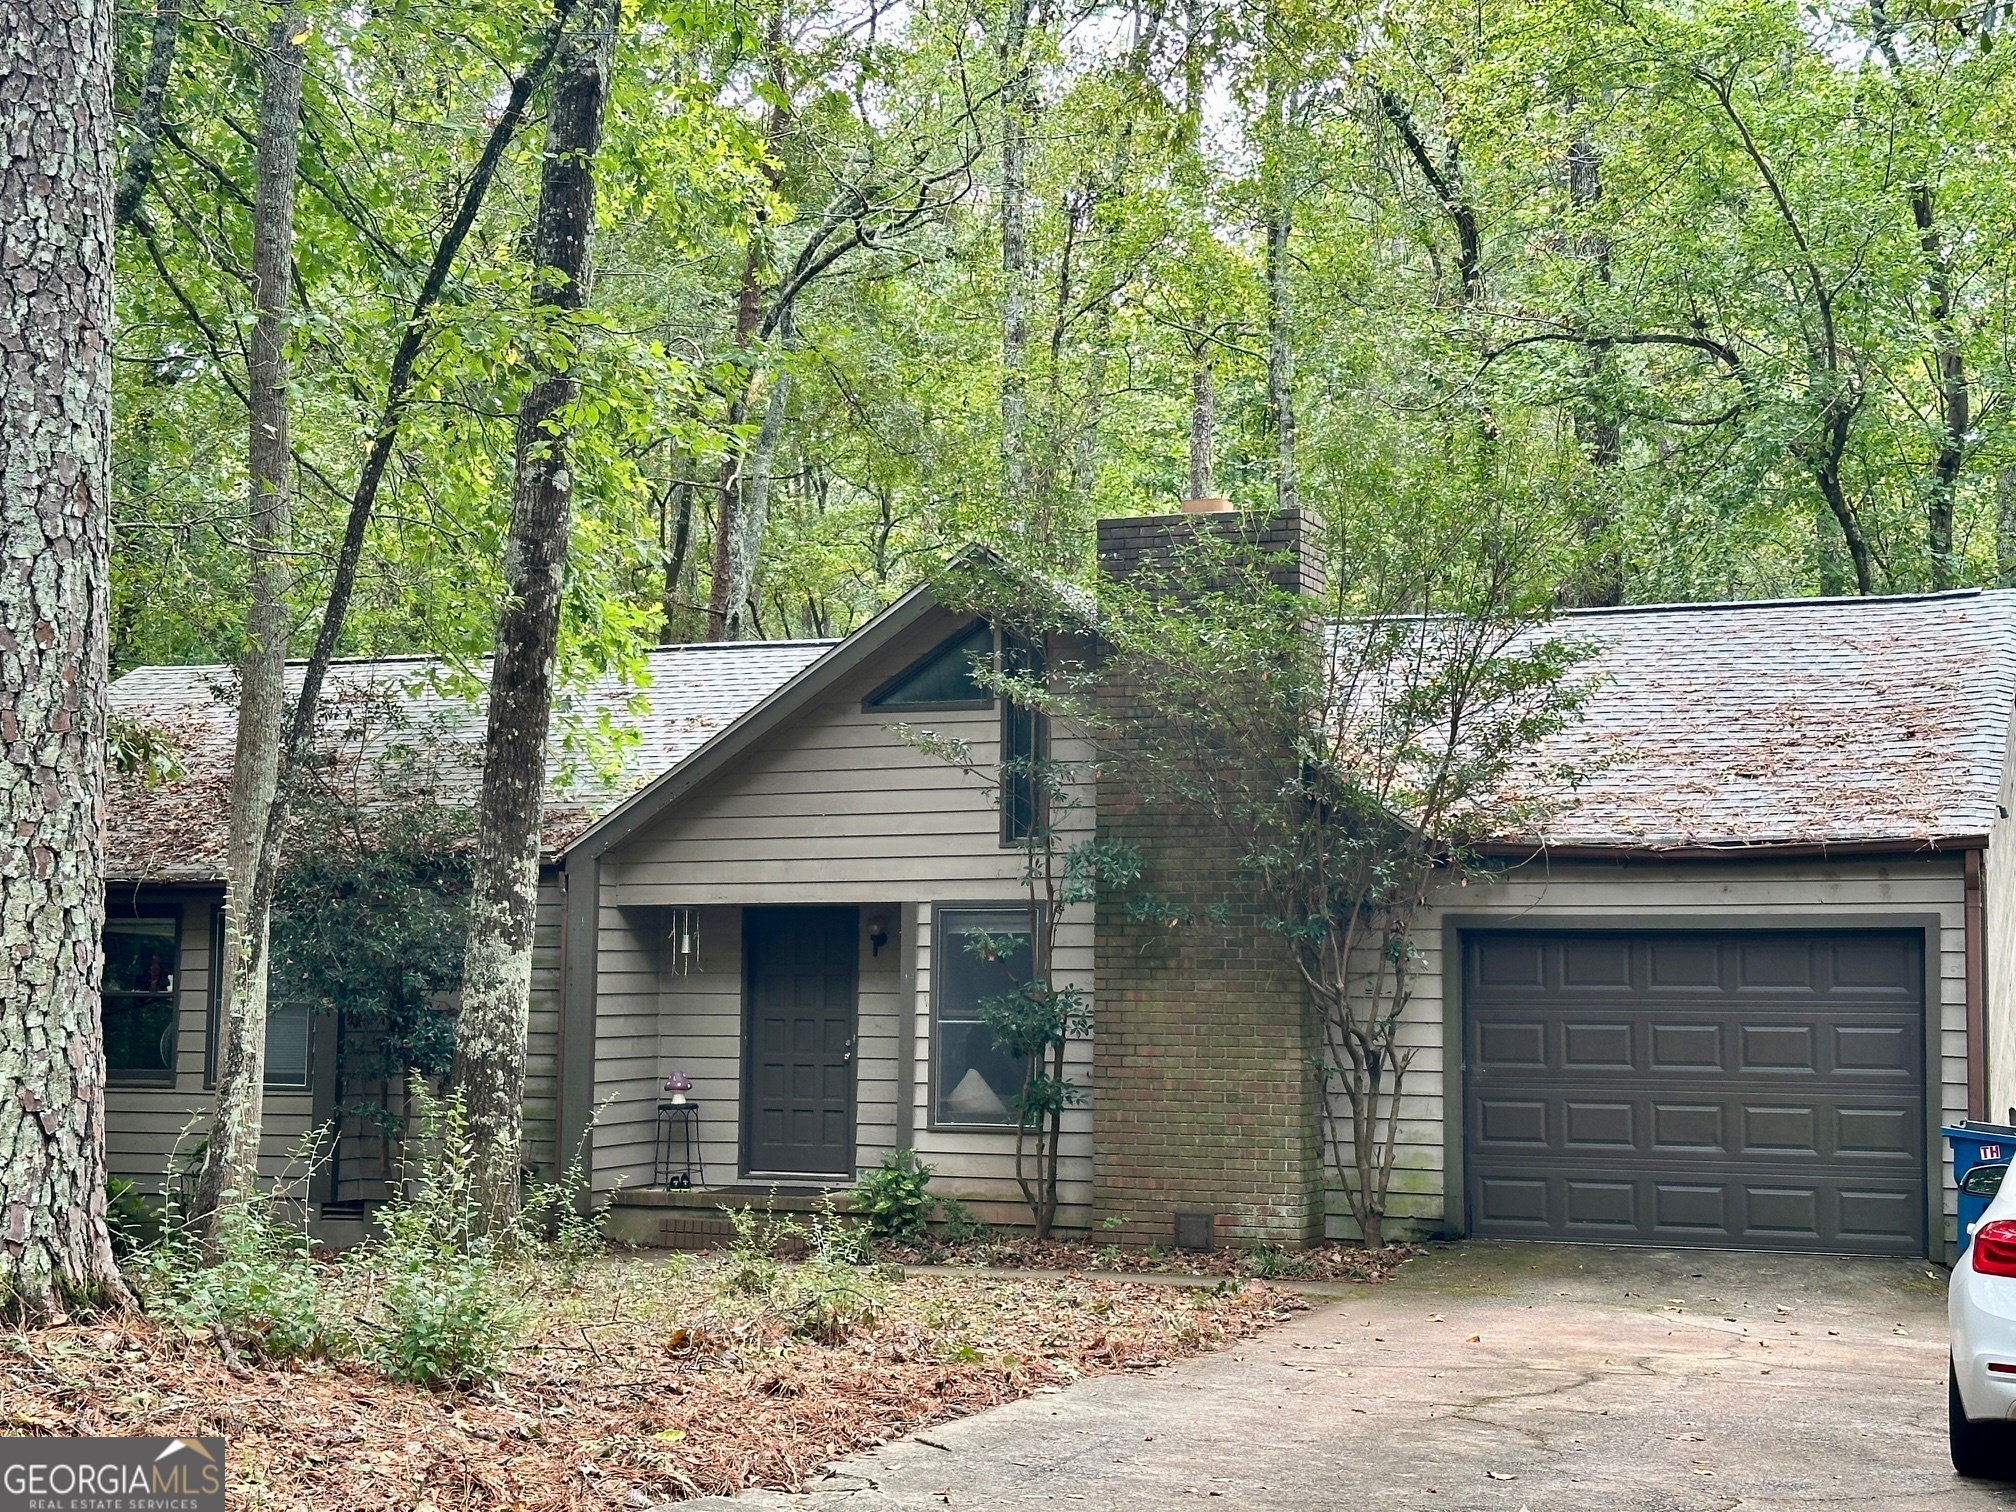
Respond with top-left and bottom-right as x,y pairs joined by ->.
1091,506 -> 1325,1248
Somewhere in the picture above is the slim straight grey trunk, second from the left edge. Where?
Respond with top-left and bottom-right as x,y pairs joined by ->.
194,2 -> 306,1238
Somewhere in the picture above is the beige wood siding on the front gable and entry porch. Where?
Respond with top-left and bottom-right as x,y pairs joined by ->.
595,617 -> 1097,1224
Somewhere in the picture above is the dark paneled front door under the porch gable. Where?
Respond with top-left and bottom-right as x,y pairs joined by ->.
742,907 -> 861,1179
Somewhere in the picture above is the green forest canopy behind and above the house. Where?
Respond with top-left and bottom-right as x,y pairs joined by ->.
113,0 -> 2016,675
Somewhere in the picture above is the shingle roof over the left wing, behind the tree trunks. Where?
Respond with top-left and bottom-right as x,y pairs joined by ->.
107,641 -> 835,883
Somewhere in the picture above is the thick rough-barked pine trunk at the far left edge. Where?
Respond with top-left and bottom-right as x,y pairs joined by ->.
0,0 -> 131,1318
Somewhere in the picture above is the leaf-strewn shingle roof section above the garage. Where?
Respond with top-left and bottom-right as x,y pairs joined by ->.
1494,591 -> 2016,851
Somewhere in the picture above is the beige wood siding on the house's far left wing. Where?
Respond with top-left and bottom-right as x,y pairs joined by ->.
105,893 -> 314,1191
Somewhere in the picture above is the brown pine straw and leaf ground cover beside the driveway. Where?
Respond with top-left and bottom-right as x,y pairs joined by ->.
0,1254 -> 1308,1512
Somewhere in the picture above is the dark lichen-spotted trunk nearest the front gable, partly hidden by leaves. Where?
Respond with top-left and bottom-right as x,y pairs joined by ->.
454,0 -> 617,1228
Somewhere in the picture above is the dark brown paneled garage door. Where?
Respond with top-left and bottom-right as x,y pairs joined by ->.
1464,931 -> 1925,1254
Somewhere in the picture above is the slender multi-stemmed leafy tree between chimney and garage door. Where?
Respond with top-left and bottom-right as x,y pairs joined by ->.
939,504 -> 1585,1246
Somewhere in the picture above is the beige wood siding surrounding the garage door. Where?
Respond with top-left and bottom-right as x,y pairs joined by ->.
1329,855 -> 1968,1236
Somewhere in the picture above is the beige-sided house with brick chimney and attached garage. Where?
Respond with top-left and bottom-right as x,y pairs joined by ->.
107,514 -> 2016,1256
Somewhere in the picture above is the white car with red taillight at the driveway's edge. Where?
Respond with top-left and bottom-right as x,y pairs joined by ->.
1945,1165 -> 2016,1480
